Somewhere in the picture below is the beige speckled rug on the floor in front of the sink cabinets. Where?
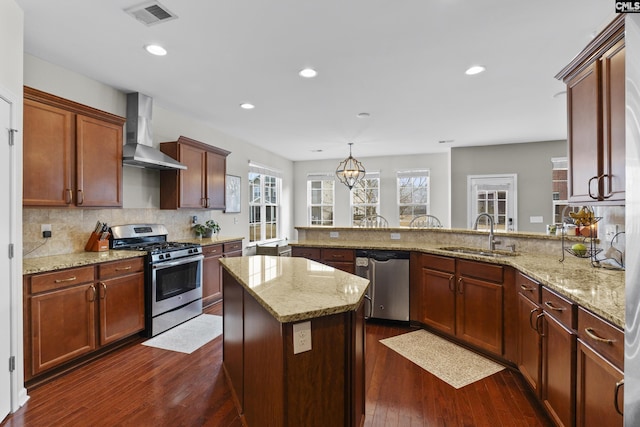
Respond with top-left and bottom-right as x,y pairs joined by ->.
380,329 -> 504,388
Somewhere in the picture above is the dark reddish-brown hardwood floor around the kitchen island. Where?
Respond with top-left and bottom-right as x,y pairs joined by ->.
1,304 -> 551,427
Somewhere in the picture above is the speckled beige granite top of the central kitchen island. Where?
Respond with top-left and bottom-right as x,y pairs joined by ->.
220,255 -> 369,323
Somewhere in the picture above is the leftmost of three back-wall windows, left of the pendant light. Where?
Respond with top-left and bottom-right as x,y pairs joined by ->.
307,174 -> 335,226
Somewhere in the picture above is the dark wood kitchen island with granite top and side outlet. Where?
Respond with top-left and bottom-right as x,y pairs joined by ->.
220,255 -> 369,426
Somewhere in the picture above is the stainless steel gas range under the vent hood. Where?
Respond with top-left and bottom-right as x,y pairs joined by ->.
109,224 -> 204,336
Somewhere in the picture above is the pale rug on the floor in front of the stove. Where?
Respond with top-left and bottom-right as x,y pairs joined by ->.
142,314 -> 222,354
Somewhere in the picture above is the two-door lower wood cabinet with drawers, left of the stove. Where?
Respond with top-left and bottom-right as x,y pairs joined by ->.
23,258 -> 145,382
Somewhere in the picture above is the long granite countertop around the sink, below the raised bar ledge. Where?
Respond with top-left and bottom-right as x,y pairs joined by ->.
289,240 -> 625,329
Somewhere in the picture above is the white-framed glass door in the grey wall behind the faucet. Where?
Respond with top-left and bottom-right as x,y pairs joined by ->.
467,174 -> 518,231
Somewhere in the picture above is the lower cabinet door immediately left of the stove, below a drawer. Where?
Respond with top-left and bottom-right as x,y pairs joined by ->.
98,273 -> 144,345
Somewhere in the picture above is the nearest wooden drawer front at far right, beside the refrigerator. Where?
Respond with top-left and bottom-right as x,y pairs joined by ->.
578,307 -> 624,369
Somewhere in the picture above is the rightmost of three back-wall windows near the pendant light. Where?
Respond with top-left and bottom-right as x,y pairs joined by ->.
397,170 -> 429,227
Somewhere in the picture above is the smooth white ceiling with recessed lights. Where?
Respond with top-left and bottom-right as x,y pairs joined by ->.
17,0 -> 614,160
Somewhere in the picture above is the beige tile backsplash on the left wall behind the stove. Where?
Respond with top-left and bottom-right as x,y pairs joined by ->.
22,208 -> 222,258
